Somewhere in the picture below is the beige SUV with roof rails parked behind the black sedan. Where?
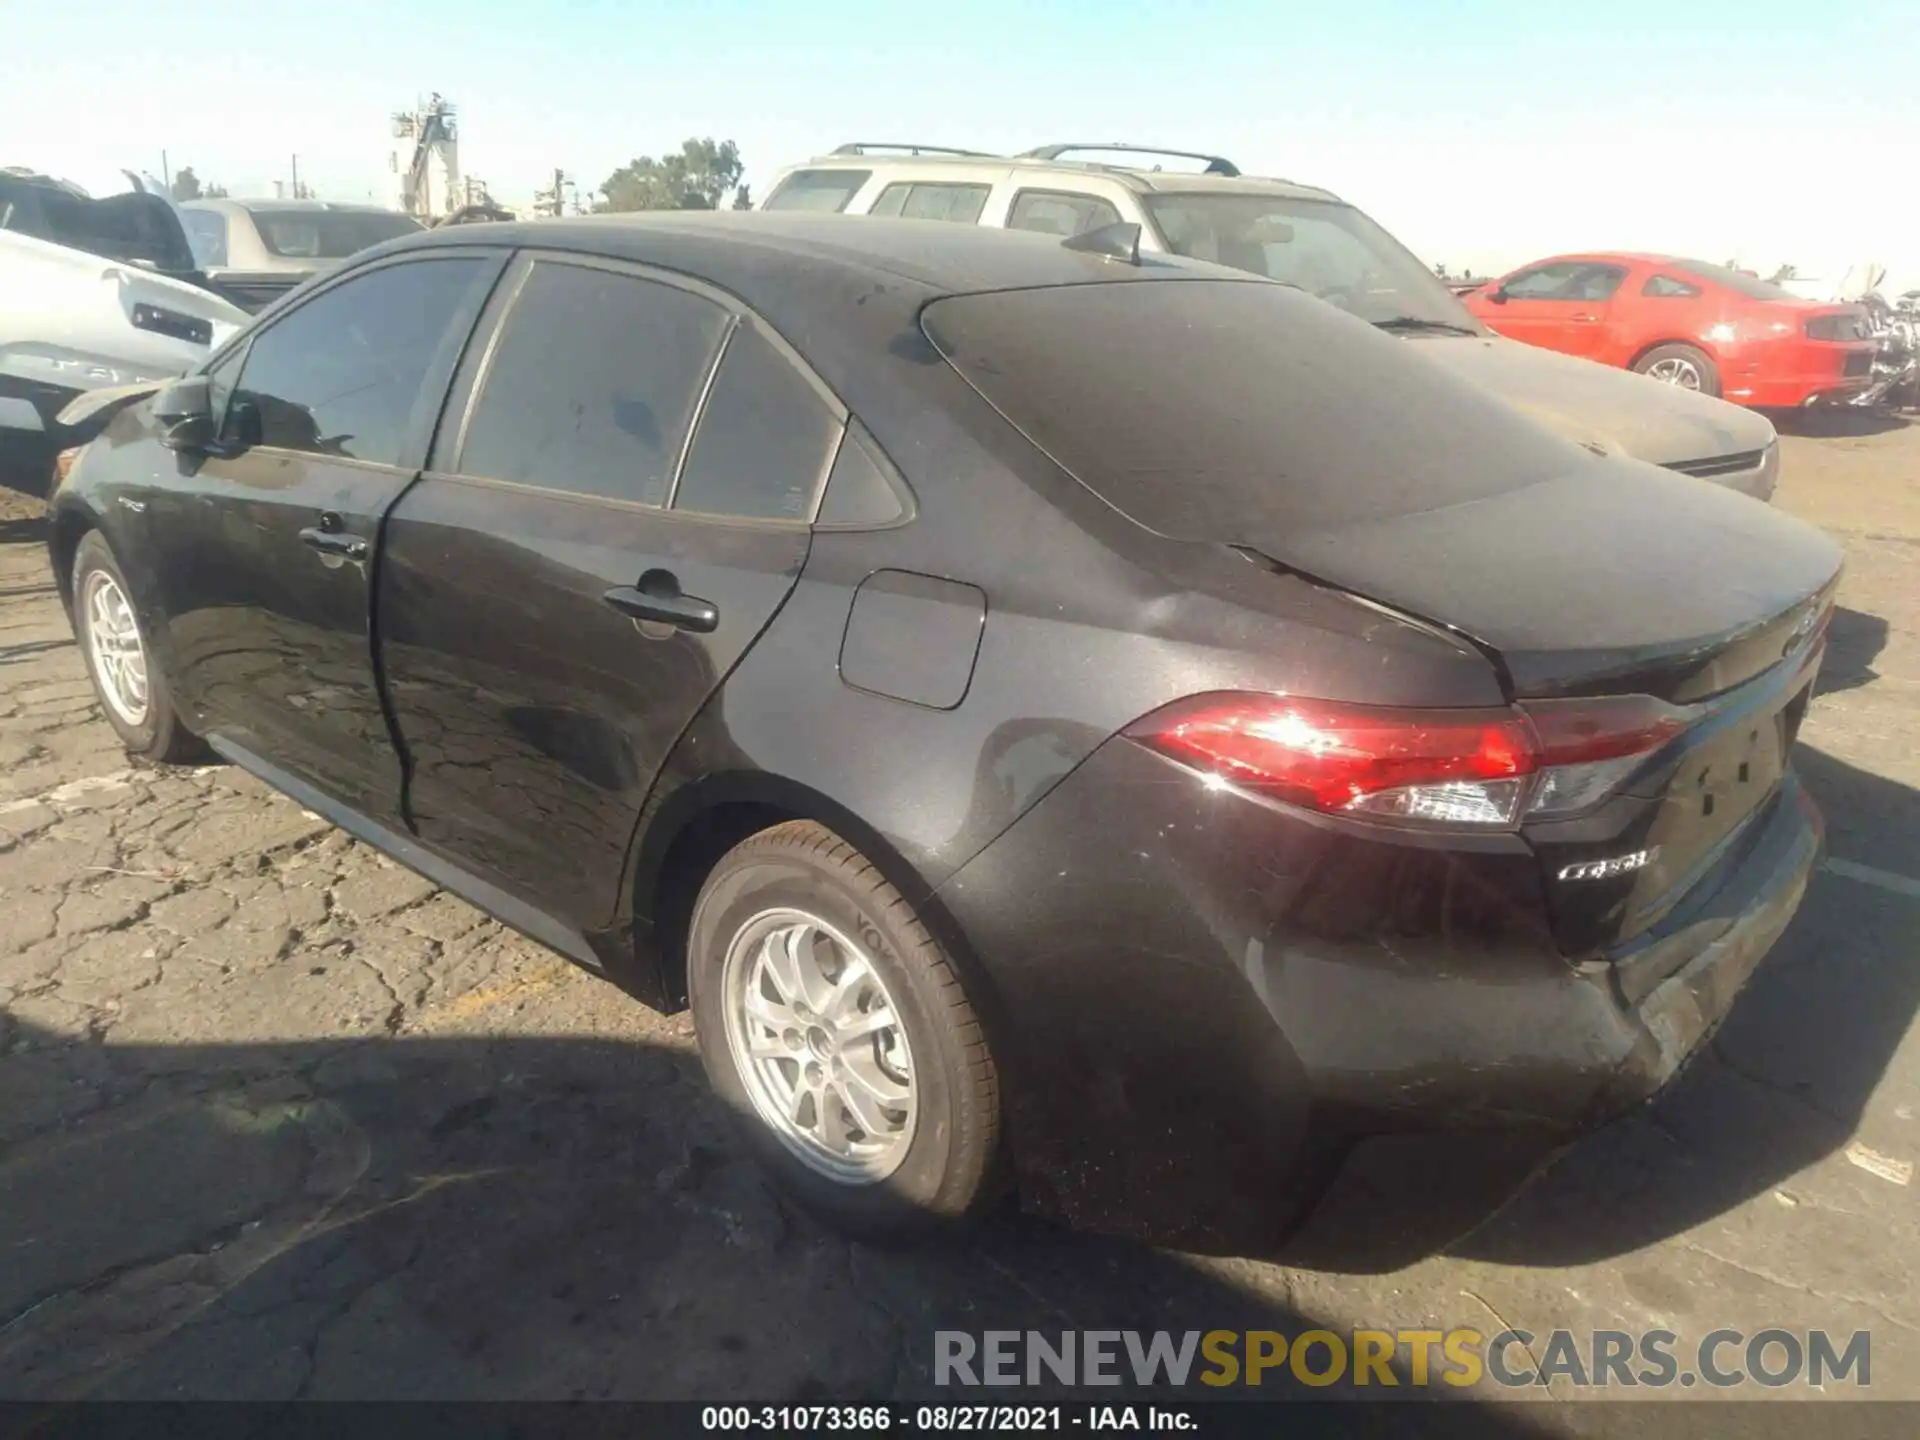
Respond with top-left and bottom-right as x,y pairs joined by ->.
758,144 -> 1780,499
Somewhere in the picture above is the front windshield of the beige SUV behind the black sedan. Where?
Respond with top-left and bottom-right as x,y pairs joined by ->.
1142,194 -> 1480,334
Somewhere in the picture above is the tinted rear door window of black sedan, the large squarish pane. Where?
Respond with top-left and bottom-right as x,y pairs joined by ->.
457,261 -> 728,505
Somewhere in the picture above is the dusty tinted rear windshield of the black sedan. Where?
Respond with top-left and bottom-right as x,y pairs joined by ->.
922,280 -> 1582,543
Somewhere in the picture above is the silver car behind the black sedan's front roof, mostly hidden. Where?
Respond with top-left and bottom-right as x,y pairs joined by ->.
180,200 -> 426,311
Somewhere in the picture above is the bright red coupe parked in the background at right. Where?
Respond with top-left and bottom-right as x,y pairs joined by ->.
1463,253 -> 1876,409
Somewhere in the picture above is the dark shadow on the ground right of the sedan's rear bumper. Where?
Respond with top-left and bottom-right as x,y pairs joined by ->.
1452,745 -> 1920,1265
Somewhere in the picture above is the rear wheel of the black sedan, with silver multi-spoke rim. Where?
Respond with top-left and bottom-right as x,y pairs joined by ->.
687,822 -> 1000,1233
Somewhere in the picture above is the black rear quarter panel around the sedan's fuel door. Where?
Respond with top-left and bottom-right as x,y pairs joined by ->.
634,369 -> 1500,952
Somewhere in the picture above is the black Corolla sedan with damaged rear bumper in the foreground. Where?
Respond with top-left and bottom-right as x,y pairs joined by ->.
50,215 -> 1839,1267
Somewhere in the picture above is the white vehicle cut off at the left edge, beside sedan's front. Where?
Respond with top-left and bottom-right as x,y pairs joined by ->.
0,169 -> 250,495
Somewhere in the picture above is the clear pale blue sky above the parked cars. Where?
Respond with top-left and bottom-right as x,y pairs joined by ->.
0,0 -> 1920,284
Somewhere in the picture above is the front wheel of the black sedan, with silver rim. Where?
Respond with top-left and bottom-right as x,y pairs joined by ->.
73,530 -> 205,764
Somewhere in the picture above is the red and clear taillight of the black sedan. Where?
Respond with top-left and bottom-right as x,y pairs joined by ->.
1127,693 -> 1690,828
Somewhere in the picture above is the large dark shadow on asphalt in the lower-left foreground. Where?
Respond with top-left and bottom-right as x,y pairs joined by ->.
0,1021 -> 1540,1436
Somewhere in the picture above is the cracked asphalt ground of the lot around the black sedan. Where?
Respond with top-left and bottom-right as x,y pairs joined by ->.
0,424 -> 1920,1434
